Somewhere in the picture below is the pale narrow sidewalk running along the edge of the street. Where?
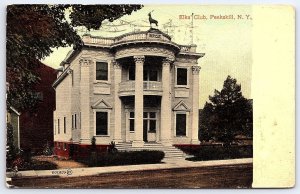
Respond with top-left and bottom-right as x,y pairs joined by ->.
6,158 -> 252,178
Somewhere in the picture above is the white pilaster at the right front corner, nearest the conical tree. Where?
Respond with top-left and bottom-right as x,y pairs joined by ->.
191,66 -> 200,144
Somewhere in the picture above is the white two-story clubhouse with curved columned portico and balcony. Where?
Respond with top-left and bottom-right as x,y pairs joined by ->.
53,28 -> 204,157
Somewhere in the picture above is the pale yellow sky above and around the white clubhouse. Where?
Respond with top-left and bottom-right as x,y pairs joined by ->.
42,5 -> 255,108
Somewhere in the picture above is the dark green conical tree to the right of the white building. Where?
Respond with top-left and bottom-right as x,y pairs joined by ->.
199,76 -> 253,144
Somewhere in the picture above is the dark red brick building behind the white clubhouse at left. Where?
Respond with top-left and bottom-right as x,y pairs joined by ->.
20,63 -> 56,153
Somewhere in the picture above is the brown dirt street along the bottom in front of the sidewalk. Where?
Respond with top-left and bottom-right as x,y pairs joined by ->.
8,164 -> 252,189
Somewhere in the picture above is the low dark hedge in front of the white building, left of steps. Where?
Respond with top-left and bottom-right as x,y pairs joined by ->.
78,150 -> 165,166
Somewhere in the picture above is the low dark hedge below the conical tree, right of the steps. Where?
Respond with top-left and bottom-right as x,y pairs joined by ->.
184,146 -> 253,161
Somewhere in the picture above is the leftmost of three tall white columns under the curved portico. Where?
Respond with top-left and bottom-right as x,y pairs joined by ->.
113,61 -> 122,142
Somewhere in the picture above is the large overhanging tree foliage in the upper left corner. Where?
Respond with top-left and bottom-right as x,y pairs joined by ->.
6,4 -> 142,111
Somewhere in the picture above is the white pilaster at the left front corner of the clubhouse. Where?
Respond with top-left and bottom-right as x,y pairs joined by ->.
78,59 -> 92,144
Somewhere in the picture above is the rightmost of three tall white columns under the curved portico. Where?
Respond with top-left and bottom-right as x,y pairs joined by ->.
160,58 -> 172,145
